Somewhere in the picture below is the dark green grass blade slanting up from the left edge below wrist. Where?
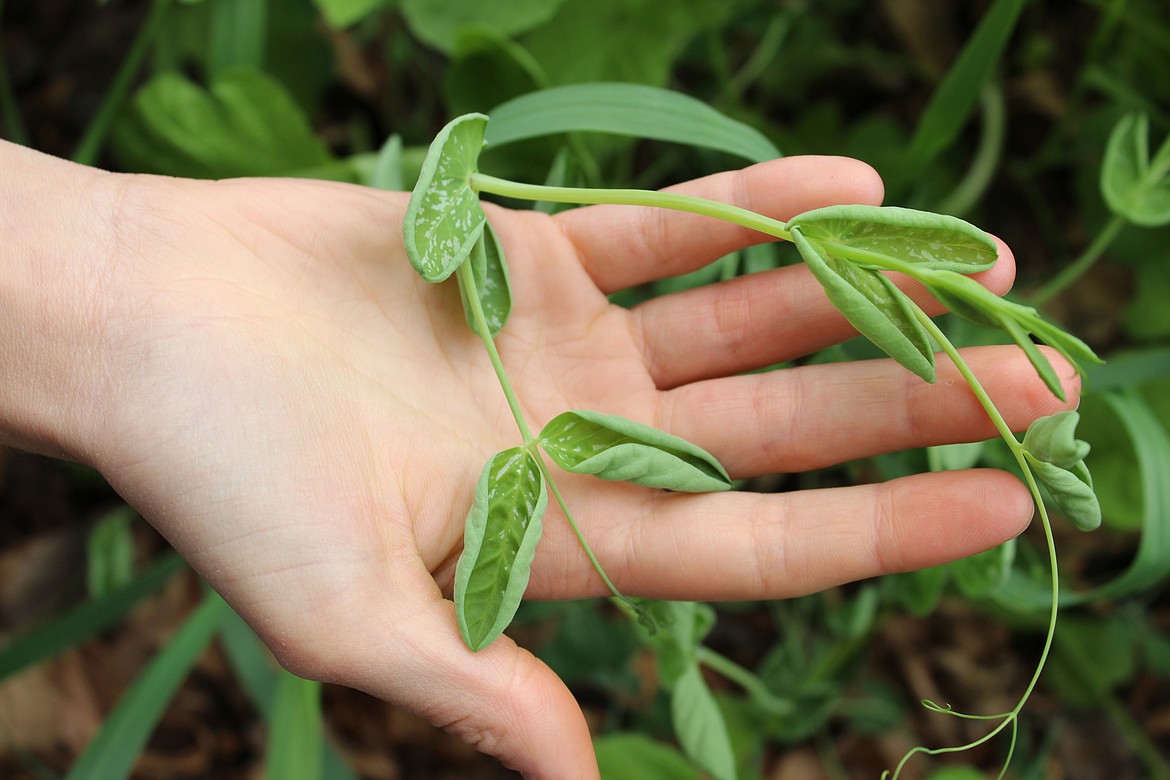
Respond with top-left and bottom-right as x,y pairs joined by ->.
0,552 -> 186,679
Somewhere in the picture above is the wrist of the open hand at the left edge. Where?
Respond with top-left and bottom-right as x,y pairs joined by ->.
0,141 -> 125,461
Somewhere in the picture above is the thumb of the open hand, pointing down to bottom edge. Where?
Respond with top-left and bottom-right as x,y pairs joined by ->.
320,568 -> 599,780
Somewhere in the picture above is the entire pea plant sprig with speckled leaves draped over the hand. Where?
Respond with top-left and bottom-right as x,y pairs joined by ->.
404,113 -> 1101,779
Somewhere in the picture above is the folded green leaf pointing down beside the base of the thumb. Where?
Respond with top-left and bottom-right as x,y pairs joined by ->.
455,447 -> 549,650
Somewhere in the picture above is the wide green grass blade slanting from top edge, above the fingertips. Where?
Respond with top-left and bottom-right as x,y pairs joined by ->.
899,0 -> 1027,185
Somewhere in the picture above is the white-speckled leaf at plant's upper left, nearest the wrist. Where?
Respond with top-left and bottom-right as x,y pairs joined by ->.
402,113 -> 488,282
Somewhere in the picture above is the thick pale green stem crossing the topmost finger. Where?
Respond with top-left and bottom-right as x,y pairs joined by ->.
470,173 -> 791,241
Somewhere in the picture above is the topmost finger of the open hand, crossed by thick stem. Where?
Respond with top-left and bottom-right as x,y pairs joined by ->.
556,157 -> 885,292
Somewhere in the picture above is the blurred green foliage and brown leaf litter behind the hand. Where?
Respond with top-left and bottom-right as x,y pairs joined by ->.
0,0 -> 1170,780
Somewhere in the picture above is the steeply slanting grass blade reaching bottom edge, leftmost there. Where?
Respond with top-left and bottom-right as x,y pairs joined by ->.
66,592 -> 230,780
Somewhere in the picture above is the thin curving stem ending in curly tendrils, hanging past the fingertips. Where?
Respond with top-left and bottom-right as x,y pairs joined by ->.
879,306 -> 1060,780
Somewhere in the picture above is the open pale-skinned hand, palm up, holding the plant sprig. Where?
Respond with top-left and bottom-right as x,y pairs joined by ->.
0,137 -> 1079,780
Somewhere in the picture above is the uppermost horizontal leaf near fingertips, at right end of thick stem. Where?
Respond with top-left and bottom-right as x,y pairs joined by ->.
787,206 -> 999,274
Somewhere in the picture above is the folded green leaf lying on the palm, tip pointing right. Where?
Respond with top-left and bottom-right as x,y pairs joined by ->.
539,412 -> 731,492
